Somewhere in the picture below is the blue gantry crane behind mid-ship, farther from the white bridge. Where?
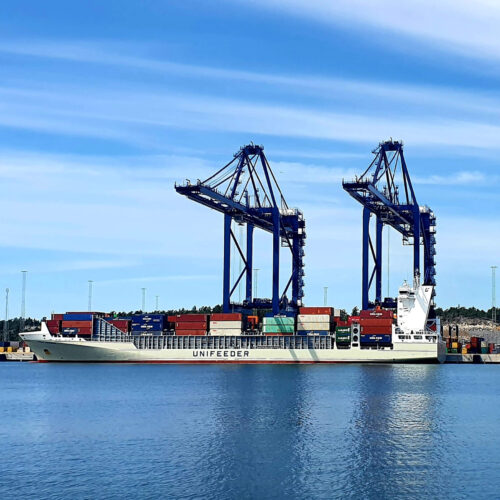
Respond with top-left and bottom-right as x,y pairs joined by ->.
175,144 -> 306,314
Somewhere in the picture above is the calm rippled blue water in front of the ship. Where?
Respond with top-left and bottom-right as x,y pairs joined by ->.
0,363 -> 500,499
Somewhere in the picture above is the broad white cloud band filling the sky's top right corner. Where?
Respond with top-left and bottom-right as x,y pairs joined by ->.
242,0 -> 500,59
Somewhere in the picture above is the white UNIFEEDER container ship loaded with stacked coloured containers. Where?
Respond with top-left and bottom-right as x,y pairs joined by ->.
21,283 -> 446,363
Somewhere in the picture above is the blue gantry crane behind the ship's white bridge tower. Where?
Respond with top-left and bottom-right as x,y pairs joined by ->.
342,139 -> 436,309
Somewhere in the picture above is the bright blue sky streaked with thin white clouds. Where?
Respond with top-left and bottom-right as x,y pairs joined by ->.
0,0 -> 500,317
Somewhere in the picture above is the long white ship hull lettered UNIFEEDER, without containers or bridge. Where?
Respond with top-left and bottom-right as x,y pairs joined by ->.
25,334 -> 446,364
